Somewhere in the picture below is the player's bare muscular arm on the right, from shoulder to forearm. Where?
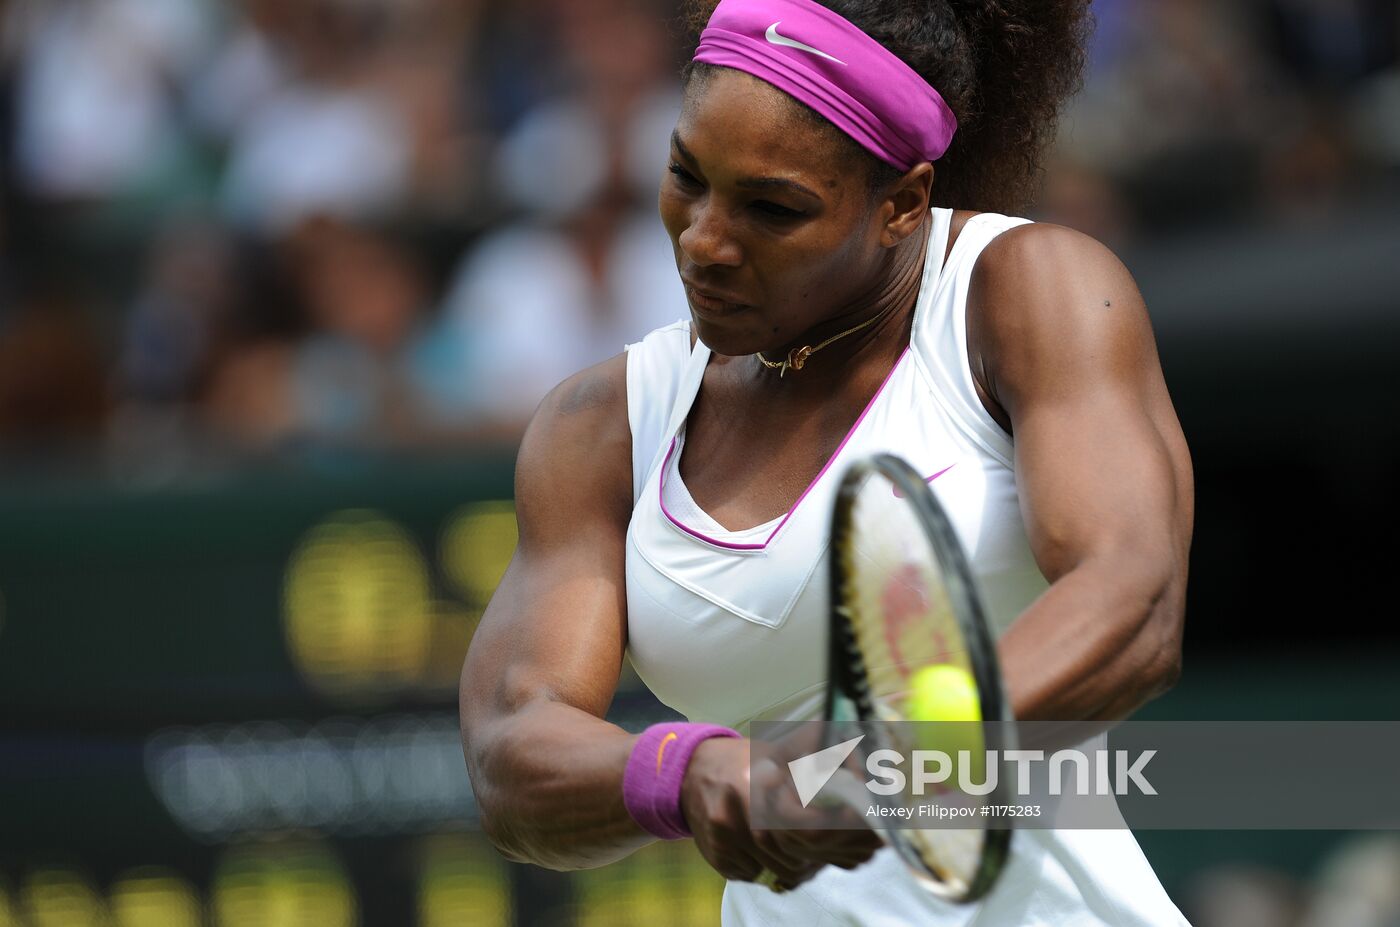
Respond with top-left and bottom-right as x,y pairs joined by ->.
967,225 -> 1193,721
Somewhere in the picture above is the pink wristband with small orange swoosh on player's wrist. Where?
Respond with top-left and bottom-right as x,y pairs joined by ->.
622,721 -> 743,840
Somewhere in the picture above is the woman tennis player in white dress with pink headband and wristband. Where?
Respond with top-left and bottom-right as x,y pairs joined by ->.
461,0 -> 1191,927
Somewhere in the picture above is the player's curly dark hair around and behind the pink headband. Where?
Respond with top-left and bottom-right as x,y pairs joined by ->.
685,0 -> 1092,214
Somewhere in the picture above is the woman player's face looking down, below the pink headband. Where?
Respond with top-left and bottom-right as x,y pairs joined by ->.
661,69 -> 888,356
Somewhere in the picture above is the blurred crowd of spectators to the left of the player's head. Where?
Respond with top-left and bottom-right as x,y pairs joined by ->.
0,0 -> 686,459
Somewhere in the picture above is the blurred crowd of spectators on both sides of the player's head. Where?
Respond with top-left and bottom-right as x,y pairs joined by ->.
0,0 -> 1400,464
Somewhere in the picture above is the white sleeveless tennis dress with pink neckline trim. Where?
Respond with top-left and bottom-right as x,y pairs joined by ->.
627,209 -> 1186,927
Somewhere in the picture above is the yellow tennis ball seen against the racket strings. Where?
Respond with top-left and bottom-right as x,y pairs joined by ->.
904,664 -> 986,787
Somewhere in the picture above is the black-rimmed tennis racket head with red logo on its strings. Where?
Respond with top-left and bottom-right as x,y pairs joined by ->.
826,454 -> 1014,902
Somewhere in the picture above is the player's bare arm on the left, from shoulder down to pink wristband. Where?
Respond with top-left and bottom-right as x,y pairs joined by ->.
461,357 -> 652,870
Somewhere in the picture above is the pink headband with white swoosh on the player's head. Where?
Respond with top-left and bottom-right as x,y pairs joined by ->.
694,0 -> 958,171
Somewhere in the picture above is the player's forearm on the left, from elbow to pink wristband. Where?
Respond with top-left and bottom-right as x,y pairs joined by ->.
463,699 -> 655,870
